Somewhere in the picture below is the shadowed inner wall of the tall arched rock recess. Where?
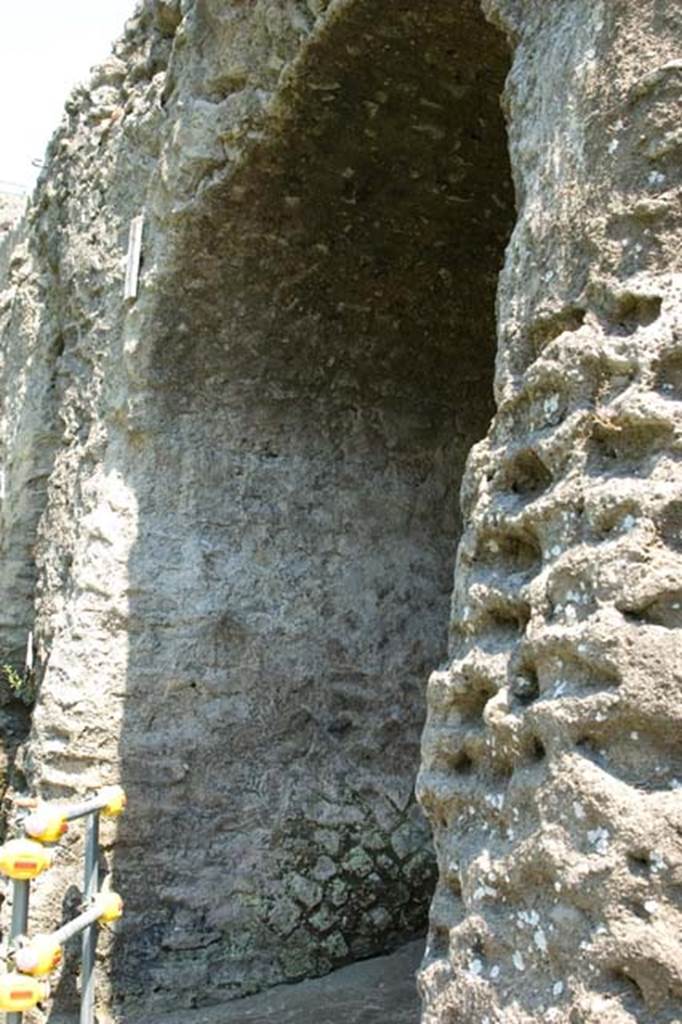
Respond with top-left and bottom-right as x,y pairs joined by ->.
106,0 -> 513,1014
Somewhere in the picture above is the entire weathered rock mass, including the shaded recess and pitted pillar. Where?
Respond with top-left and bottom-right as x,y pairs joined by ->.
0,0 -> 682,1024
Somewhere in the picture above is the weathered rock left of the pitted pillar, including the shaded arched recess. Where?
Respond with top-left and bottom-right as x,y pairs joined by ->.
3,0 -> 512,1018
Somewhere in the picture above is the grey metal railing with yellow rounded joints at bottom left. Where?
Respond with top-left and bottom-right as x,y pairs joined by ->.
0,785 -> 126,1024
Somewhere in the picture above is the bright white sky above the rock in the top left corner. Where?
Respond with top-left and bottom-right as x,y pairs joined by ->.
0,0 -> 135,191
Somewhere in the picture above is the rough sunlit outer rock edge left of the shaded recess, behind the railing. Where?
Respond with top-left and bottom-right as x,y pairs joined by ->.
0,5 -> 172,1009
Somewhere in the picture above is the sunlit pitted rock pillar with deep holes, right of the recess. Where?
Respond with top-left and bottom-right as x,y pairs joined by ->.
419,2 -> 682,1024
